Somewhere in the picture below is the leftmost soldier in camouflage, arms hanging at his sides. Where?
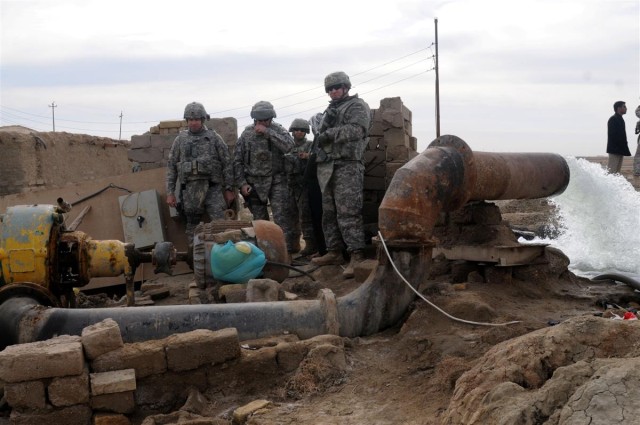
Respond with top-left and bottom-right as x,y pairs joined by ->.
167,102 -> 235,247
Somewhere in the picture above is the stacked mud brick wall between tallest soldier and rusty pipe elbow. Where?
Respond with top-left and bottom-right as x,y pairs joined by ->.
362,97 -> 418,235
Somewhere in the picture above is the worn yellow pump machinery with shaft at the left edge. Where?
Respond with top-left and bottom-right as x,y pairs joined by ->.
0,203 -> 176,307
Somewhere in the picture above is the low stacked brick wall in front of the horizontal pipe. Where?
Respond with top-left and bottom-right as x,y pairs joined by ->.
0,319 -> 346,425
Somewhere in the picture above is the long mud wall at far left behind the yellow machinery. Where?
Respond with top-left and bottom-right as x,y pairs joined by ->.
0,131 -> 131,196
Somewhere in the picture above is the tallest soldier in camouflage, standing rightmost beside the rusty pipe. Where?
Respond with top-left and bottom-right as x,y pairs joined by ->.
311,72 -> 371,278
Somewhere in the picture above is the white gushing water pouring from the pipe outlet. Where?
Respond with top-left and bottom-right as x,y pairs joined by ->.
546,157 -> 640,277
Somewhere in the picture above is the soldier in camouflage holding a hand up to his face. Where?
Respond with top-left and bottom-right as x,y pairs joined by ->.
233,101 -> 300,253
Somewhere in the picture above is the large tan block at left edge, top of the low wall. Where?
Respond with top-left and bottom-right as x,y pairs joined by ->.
0,335 -> 84,382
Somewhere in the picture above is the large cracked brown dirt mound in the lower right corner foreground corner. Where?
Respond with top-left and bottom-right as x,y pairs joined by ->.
442,316 -> 640,424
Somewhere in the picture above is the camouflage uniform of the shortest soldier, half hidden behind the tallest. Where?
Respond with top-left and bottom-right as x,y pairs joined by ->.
285,133 -> 316,252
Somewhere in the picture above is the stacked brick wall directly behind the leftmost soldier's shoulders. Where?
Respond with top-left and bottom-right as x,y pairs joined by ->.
129,117 -> 238,170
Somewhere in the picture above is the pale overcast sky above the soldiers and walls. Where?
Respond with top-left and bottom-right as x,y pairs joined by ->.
0,0 -> 640,156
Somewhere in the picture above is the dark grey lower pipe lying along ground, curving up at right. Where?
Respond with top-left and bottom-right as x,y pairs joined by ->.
0,243 -> 431,348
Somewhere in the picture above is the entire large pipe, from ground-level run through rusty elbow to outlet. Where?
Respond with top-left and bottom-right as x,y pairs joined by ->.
0,136 -> 569,346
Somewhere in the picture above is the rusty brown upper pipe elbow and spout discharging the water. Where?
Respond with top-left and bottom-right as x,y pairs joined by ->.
378,135 -> 569,244
